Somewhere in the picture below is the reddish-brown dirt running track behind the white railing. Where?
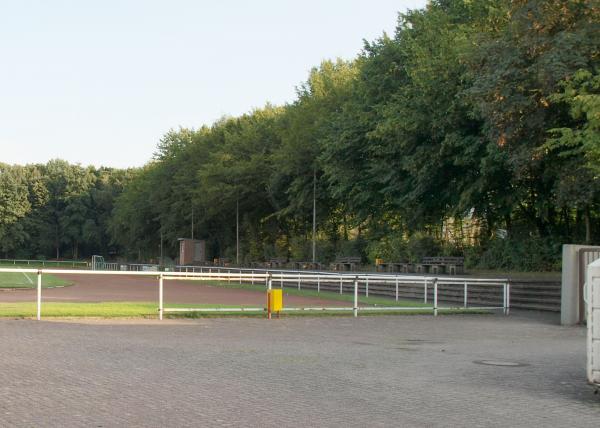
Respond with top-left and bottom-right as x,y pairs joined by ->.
0,275 -> 351,307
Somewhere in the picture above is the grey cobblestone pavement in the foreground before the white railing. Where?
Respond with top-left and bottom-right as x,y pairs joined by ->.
0,315 -> 600,427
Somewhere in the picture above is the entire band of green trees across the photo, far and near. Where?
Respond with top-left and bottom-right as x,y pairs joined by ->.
0,0 -> 600,269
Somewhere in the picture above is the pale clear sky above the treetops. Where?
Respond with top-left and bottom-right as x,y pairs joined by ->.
0,0 -> 426,168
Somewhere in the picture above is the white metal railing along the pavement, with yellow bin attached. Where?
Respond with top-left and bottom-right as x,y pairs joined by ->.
0,267 -> 510,320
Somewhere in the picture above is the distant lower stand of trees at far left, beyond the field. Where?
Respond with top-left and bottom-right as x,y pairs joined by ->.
0,160 -> 132,259
